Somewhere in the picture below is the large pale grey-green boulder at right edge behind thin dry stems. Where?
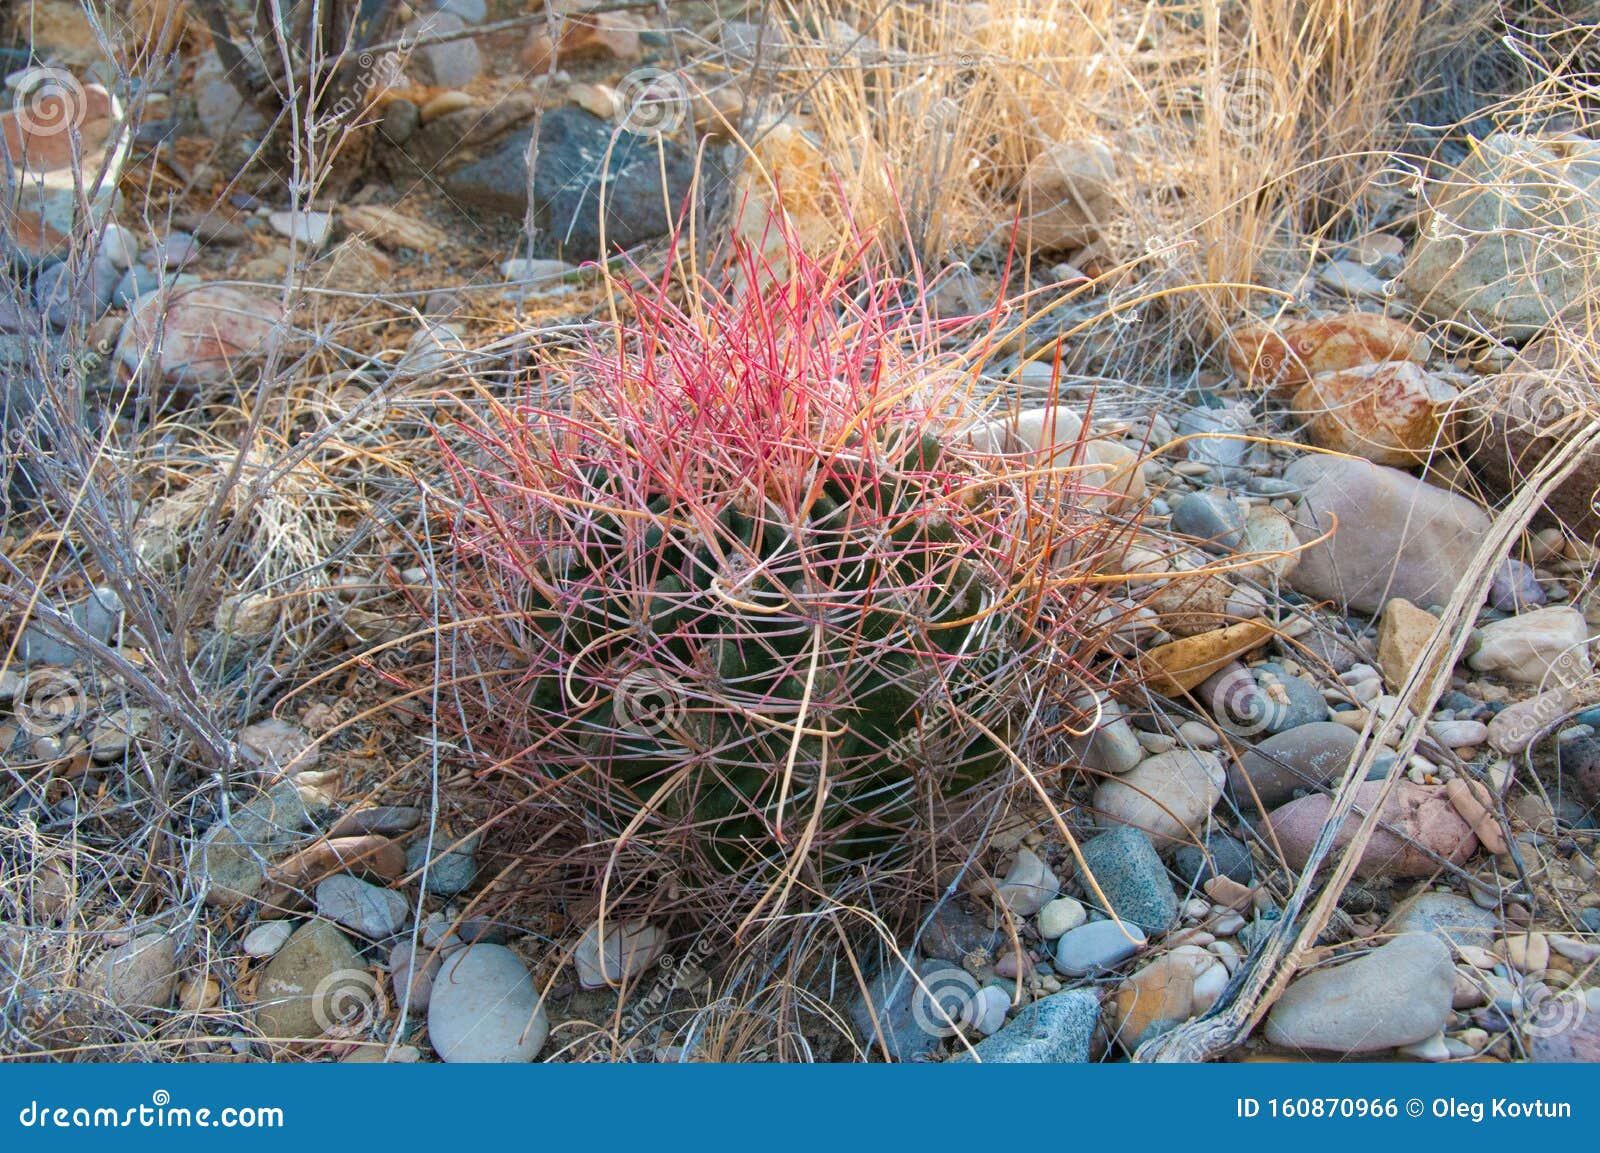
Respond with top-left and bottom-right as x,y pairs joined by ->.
1402,133 -> 1600,341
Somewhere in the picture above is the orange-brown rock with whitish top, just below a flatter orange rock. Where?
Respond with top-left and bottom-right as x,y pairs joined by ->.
1293,360 -> 1458,465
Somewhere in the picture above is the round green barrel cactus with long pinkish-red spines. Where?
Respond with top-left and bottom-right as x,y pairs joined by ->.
432,244 -> 1102,908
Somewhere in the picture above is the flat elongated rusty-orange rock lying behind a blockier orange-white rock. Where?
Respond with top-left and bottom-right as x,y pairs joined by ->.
1227,312 -> 1432,397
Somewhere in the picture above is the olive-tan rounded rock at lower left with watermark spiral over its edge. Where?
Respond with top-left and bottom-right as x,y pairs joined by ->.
256,921 -> 374,1041
